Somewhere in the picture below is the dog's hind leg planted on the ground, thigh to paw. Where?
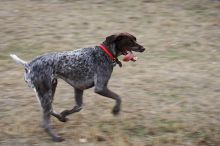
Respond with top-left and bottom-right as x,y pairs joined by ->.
35,82 -> 64,142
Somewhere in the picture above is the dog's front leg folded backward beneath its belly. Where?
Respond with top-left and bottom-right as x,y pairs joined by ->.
60,88 -> 83,118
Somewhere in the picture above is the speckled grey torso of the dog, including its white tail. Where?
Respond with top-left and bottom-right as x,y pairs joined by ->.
10,47 -> 113,89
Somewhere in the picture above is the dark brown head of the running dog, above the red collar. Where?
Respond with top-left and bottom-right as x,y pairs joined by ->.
104,33 -> 145,57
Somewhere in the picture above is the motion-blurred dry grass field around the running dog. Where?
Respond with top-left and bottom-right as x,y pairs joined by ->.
0,0 -> 220,146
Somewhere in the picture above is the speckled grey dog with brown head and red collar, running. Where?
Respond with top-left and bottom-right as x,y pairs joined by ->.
10,33 -> 145,141
